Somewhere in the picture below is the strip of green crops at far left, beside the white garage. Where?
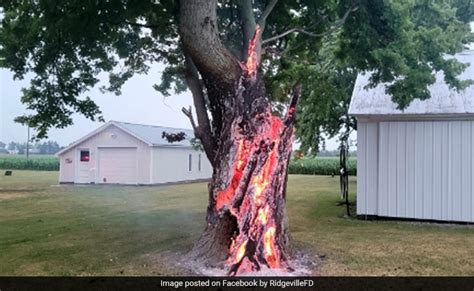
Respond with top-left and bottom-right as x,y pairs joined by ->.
0,154 -> 59,171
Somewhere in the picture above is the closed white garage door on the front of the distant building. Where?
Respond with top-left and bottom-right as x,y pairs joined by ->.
99,148 -> 137,184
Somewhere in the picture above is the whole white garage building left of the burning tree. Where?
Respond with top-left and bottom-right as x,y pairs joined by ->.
56,121 -> 212,185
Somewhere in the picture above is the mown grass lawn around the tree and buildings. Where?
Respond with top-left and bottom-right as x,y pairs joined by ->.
0,170 -> 474,276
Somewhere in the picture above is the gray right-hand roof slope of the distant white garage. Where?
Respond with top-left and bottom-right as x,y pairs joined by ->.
110,121 -> 194,147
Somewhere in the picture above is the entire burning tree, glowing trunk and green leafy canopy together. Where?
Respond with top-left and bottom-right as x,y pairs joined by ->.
0,0 -> 472,275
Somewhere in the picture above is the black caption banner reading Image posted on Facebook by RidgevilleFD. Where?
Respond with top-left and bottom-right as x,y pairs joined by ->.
0,277 -> 474,291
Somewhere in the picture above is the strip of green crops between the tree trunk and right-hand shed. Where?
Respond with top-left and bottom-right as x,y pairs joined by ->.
289,157 -> 357,176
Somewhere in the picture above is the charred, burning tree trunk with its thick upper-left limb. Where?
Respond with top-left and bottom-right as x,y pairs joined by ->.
180,0 -> 300,275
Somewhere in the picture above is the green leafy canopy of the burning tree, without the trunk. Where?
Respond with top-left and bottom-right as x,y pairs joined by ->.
0,0 -> 473,148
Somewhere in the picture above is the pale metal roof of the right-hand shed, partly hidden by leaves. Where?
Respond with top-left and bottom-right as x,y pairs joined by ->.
349,50 -> 474,116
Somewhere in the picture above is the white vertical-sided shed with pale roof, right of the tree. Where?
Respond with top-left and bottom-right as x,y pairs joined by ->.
349,51 -> 474,222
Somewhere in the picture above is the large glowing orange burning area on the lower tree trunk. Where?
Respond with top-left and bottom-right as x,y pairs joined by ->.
216,116 -> 283,275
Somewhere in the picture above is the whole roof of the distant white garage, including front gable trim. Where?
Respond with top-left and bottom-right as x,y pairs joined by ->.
56,120 -> 194,156
